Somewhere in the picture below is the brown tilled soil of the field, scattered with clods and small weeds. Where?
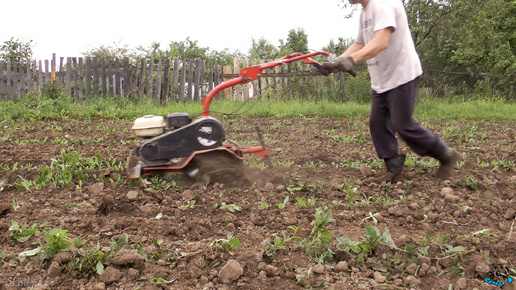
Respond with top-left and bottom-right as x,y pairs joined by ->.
0,117 -> 516,289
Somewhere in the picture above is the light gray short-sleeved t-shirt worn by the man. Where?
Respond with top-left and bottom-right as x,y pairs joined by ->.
357,0 -> 423,93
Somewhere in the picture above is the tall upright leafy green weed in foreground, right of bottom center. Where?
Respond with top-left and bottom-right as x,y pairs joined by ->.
299,209 -> 334,263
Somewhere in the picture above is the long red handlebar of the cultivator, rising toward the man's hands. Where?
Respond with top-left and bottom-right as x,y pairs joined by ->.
202,51 -> 338,117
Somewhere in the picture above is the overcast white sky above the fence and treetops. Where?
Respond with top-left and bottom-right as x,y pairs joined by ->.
0,0 -> 358,59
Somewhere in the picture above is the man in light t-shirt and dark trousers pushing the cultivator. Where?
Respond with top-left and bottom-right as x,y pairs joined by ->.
320,0 -> 461,183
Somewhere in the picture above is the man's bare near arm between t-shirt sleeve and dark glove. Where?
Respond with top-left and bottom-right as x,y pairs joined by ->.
341,27 -> 394,64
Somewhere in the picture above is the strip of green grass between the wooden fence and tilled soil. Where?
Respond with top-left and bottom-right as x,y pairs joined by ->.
0,94 -> 516,123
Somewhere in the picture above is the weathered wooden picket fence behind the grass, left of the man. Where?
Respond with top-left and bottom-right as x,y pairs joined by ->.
0,54 -> 345,103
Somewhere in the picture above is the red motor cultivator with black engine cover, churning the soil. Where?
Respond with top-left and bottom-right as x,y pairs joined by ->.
127,51 -> 346,179
